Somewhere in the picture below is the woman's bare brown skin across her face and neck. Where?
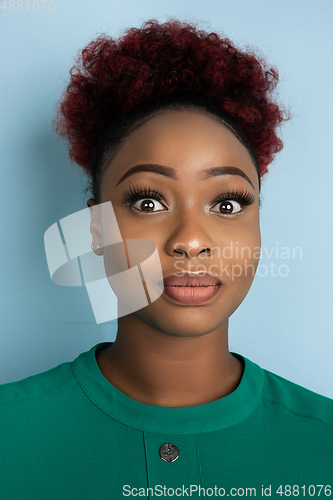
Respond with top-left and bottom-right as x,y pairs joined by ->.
87,110 -> 261,407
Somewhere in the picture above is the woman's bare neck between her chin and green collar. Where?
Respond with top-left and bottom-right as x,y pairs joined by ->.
96,315 -> 243,406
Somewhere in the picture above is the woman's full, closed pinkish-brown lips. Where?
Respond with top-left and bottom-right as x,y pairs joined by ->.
164,273 -> 222,305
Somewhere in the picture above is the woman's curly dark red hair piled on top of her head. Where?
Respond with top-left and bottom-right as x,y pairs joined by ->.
54,19 -> 288,177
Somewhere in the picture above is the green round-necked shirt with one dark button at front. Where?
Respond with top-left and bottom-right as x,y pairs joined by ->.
0,342 -> 333,500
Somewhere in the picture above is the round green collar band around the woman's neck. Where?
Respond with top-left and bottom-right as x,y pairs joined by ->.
72,342 -> 265,434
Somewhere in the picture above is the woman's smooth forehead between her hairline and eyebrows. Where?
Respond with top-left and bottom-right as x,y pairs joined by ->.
105,110 -> 259,189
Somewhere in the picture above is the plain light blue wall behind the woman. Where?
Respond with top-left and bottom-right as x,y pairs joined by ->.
0,0 -> 333,398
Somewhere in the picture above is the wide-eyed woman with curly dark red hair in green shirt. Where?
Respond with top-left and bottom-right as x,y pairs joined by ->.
0,19 -> 333,500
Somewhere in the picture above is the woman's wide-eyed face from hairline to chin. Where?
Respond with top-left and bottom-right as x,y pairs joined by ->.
92,110 -> 261,336
